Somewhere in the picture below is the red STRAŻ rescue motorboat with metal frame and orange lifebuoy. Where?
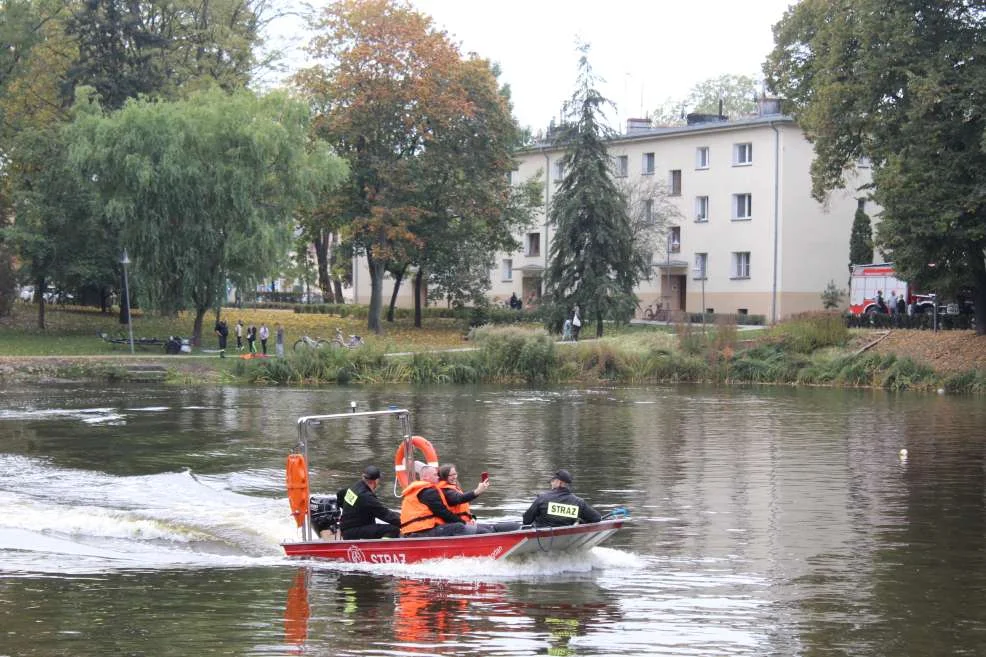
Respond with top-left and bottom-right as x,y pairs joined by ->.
282,409 -> 625,564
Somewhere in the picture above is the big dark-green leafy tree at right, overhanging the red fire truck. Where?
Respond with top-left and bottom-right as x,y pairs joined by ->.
764,0 -> 986,334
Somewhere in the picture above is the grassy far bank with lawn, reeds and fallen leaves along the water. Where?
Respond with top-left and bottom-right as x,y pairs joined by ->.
0,309 -> 986,394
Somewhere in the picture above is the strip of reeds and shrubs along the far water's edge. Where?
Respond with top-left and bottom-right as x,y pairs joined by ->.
235,313 -> 986,394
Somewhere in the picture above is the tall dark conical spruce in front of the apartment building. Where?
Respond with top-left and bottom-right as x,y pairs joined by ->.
545,46 -> 650,337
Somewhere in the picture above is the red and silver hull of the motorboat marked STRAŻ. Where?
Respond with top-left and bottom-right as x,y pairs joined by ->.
282,519 -> 624,564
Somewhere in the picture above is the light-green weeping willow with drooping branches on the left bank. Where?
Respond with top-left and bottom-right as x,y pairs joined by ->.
71,90 -> 346,343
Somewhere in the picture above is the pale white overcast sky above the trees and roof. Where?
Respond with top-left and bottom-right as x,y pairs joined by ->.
264,0 -> 795,131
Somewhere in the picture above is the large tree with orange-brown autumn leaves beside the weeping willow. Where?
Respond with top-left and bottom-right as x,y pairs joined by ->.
295,0 -> 536,332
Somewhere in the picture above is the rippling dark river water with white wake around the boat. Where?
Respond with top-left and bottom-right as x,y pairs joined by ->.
0,384 -> 986,657
